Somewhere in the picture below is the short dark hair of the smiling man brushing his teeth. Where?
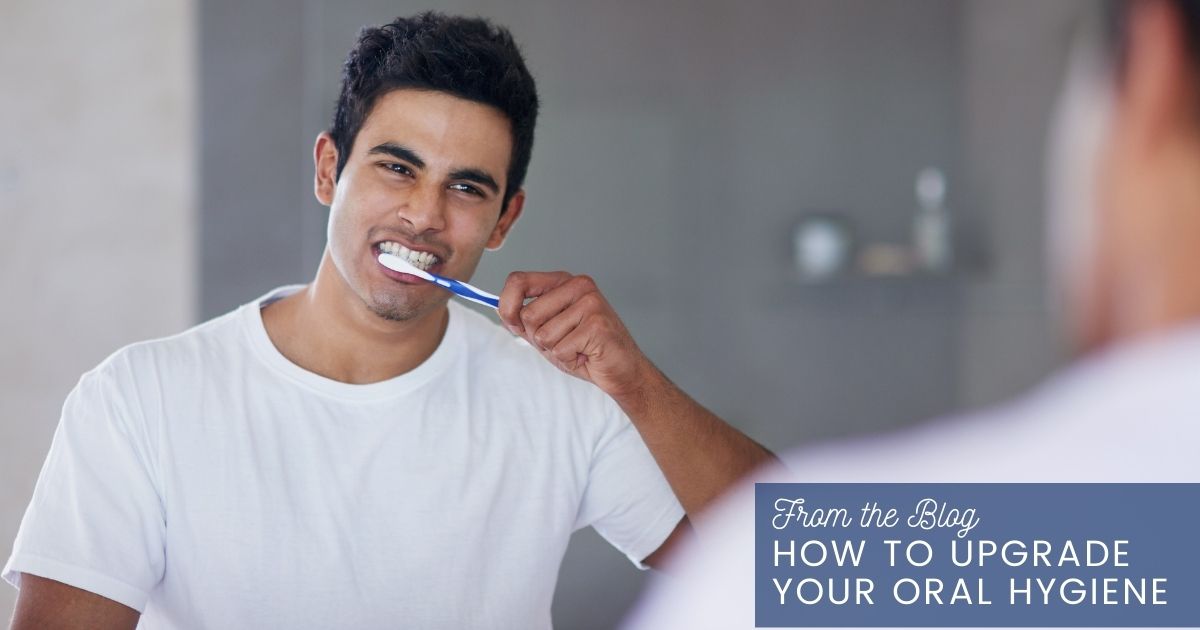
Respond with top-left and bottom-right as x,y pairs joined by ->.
329,11 -> 538,207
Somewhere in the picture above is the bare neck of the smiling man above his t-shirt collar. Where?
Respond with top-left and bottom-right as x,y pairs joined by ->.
262,259 -> 450,384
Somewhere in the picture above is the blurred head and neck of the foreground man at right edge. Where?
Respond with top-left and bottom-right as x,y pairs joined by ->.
1048,0 -> 1200,352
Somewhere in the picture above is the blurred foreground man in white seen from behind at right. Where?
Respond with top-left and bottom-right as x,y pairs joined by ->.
626,0 -> 1200,630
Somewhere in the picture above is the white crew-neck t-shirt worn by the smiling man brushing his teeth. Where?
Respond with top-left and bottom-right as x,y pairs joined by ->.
2,287 -> 683,630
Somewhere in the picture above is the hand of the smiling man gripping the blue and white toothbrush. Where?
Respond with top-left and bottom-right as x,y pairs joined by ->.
499,271 -> 653,401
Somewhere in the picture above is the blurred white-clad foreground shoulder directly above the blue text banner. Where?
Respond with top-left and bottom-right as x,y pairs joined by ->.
785,330 -> 1200,482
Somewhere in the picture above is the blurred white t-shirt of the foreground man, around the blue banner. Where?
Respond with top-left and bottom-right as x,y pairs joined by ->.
623,326 -> 1200,630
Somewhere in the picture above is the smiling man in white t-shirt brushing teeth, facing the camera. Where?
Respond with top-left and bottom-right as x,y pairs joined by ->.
4,13 -> 770,629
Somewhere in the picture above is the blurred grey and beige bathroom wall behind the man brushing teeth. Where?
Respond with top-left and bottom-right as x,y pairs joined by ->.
0,0 -> 1085,629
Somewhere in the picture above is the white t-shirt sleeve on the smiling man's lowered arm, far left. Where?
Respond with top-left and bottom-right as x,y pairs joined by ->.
0,361 -> 166,612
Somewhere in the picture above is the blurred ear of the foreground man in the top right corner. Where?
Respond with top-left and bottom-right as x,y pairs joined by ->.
1121,0 -> 1195,149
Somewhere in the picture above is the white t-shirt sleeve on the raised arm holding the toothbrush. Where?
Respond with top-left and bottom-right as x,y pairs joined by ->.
575,398 -> 684,569
